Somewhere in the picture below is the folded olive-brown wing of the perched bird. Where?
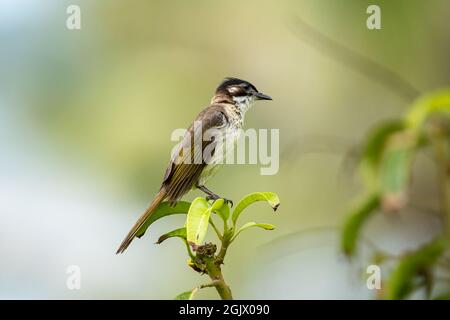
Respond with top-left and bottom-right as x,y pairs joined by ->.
163,106 -> 228,202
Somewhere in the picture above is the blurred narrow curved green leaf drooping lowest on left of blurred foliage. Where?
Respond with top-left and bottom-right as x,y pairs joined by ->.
341,193 -> 380,256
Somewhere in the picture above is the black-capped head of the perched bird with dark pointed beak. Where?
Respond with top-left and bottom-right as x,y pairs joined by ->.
215,78 -> 272,111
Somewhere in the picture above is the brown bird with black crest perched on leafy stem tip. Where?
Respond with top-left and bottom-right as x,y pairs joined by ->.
116,77 -> 272,254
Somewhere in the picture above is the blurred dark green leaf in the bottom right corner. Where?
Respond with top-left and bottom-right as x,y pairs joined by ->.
387,237 -> 446,300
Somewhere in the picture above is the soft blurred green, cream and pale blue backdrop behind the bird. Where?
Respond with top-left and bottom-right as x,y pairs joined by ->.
0,0 -> 450,299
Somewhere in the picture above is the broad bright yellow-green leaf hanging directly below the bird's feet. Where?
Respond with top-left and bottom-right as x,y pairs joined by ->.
186,197 -> 215,245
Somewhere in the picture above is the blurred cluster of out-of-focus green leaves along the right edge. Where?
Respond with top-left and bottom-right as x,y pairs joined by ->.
341,90 -> 450,299
